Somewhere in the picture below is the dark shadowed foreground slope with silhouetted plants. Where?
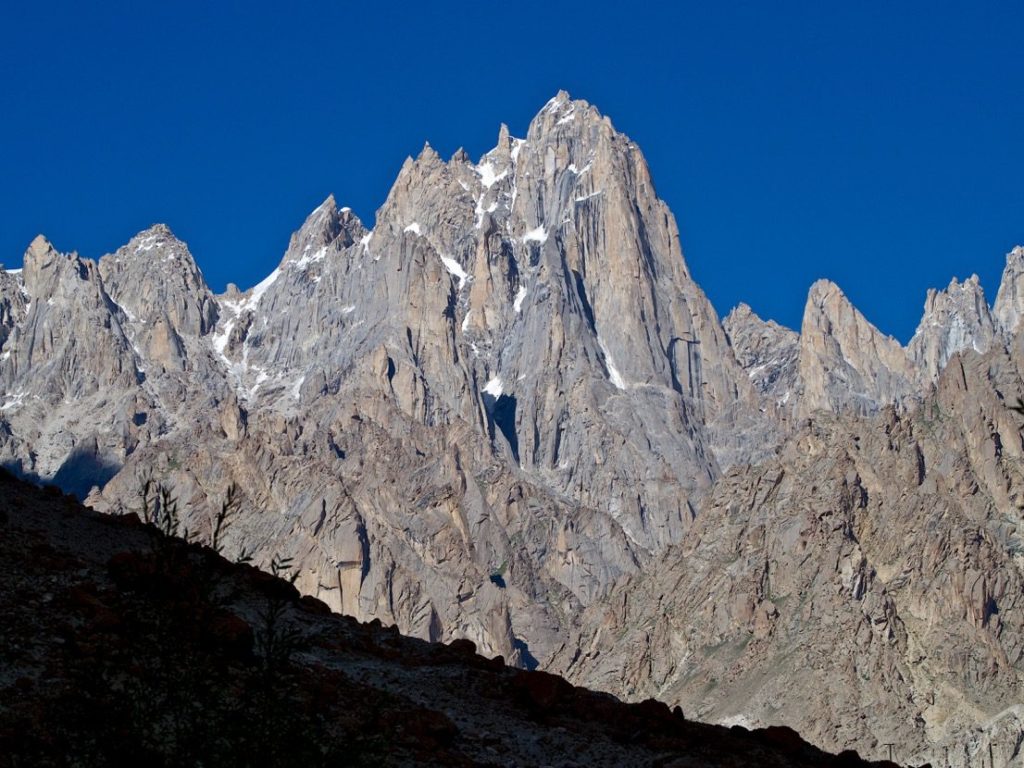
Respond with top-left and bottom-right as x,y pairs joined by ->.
0,474 -> 913,767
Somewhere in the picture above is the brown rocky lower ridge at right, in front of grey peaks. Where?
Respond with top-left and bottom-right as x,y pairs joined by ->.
552,335 -> 1024,766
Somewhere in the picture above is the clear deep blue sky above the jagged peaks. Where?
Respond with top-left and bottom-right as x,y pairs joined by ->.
0,0 -> 1024,341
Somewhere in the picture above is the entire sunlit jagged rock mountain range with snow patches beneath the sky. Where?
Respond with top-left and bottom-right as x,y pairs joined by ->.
0,93 -> 1024,758
